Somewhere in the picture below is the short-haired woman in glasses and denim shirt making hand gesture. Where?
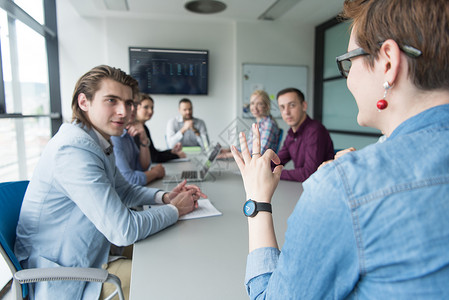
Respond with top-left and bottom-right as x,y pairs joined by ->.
232,0 -> 449,299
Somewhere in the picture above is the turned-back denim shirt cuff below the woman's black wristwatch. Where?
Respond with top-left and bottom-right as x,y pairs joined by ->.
245,247 -> 281,284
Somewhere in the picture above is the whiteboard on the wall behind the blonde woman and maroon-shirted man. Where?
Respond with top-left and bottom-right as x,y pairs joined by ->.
242,63 -> 307,118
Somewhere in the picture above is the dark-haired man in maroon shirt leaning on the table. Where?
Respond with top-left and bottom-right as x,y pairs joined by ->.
276,88 -> 334,182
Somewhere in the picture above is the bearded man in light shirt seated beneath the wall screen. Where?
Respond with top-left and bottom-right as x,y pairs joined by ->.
166,98 -> 209,148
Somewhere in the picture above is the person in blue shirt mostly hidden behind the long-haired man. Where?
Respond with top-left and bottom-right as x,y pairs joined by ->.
111,100 -> 165,185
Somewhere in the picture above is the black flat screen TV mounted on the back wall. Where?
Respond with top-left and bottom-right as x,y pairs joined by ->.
129,47 -> 209,95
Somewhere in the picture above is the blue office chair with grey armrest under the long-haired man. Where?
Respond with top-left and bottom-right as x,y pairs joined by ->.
0,181 -> 124,300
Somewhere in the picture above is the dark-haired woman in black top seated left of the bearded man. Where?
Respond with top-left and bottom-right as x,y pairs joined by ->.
134,93 -> 186,163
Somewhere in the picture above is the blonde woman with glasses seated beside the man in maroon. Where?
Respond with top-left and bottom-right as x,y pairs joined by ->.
218,90 -> 280,158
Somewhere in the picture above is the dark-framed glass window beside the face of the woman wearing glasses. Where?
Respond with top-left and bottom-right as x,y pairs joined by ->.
314,19 -> 380,149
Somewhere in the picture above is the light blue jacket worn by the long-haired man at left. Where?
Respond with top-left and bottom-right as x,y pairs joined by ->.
15,124 -> 178,299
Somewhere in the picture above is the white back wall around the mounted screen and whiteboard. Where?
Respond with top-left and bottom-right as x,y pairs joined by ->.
57,0 -> 314,149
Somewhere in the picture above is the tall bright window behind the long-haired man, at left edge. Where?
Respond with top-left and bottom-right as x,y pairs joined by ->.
0,0 -> 62,298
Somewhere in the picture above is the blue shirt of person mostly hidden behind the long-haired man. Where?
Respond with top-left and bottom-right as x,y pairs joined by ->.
111,130 -> 147,185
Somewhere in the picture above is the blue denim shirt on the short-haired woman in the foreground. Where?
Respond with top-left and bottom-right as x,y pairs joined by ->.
245,105 -> 449,299
